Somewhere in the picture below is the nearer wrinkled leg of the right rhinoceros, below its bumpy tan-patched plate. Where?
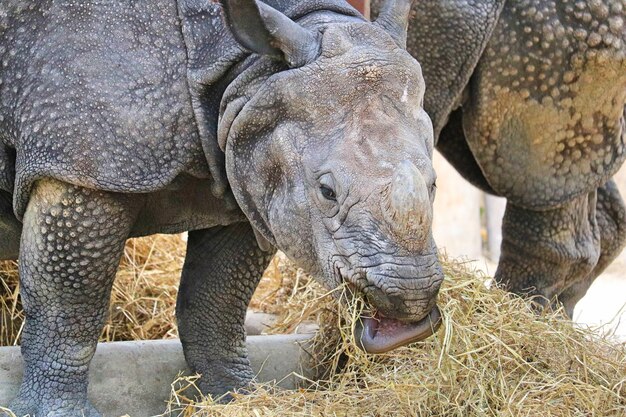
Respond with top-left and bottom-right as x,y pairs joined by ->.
495,191 -> 601,316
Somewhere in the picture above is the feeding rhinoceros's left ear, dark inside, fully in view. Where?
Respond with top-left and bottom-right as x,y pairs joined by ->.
220,0 -> 320,68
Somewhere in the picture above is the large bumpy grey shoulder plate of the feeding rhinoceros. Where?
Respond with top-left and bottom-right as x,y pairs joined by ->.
0,0 -> 209,215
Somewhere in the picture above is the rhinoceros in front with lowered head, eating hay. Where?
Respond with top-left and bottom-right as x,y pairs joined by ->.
0,0 -> 442,416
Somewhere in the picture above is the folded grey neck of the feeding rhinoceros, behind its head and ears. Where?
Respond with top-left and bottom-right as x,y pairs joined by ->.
178,0 -> 362,198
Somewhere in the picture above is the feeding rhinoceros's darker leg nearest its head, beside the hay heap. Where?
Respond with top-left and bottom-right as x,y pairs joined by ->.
176,223 -> 273,397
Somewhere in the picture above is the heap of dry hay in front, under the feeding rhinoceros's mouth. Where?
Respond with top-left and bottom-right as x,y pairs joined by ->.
163,262 -> 626,417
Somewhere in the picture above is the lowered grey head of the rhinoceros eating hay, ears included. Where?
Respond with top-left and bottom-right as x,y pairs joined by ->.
219,0 -> 443,352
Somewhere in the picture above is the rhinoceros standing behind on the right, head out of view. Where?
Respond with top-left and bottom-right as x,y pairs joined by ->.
373,0 -> 626,316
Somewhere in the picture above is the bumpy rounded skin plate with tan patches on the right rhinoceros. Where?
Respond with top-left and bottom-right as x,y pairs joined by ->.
463,0 -> 626,208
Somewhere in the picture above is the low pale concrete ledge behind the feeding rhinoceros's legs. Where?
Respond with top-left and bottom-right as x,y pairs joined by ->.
0,335 -> 311,417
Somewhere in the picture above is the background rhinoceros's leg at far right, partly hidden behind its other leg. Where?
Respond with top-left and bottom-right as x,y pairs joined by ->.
559,180 -> 626,317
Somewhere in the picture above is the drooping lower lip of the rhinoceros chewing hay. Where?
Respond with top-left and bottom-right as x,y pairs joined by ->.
354,306 -> 442,353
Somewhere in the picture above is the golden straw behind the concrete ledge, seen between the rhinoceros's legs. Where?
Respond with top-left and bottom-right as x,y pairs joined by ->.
0,235 -> 312,346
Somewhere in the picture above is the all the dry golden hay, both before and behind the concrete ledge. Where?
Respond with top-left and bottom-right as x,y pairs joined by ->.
0,236 -> 626,417
